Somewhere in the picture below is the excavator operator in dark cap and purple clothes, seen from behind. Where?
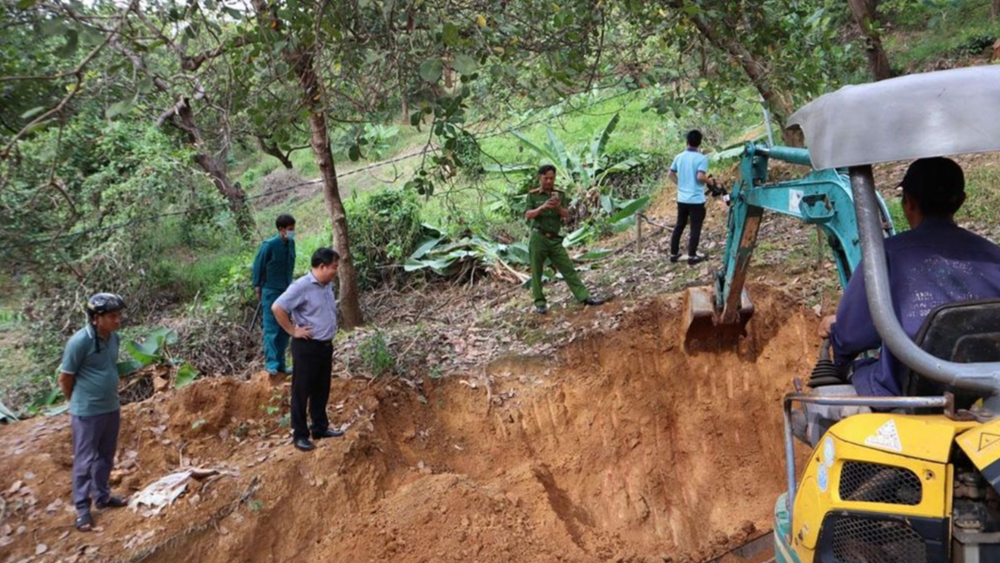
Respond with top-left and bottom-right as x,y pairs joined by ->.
819,157 -> 1000,396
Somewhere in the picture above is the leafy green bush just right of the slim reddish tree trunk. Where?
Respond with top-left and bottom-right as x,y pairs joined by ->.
347,190 -> 421,288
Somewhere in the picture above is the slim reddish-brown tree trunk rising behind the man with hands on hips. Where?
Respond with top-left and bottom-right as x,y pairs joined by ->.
293,51 -> 364,328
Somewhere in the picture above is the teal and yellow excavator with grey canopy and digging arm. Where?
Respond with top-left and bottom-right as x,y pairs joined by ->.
684,65 -> 1000,563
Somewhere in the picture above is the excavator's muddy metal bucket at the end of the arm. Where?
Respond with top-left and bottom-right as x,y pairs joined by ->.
681,287 -> 753,352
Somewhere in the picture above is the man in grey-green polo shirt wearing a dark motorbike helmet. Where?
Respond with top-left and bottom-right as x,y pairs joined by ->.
59,293 -> 127,532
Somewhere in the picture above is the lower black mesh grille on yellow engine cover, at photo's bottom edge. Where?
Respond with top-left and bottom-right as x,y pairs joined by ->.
833,517 -> 927,563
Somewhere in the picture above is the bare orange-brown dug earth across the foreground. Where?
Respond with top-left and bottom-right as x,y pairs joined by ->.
0,288 -> 817,562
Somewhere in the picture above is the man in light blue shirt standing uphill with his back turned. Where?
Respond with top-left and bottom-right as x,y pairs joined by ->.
669,129 -> 708,265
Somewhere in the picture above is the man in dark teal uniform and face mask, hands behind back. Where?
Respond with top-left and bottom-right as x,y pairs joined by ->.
253,215 -> 295,375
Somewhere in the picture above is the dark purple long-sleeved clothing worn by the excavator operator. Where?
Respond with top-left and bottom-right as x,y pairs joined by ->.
830,218 -> 1000,396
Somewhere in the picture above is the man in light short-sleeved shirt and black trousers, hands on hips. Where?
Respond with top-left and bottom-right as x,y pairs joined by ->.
271,248 -> 344,452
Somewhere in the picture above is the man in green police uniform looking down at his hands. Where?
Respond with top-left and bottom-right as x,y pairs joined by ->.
524,164 -> 604,315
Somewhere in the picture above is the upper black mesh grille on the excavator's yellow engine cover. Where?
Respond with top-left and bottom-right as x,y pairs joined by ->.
840,461 -> 922,506
